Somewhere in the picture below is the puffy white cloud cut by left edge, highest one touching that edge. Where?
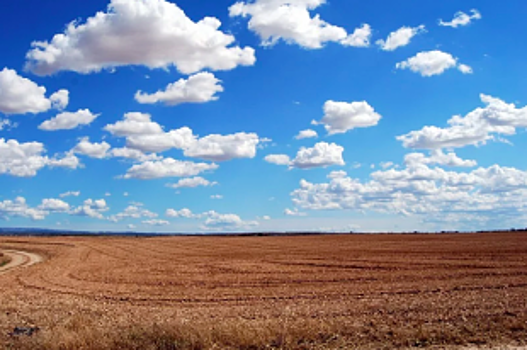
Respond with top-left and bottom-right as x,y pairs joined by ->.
0,68 -> 69,114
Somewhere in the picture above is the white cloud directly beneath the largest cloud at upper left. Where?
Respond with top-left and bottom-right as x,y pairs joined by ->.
135,72 -> 223,106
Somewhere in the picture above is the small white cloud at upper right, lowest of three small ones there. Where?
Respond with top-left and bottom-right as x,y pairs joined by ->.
396,50 -> 472,77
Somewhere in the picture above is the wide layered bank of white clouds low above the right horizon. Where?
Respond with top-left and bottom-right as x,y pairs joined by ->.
292,157 -> 527,226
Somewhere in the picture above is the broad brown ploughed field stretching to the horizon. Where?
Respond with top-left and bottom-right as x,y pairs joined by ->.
0,232 -> 527,349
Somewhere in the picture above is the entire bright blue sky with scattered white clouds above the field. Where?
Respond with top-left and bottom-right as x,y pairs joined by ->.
0,0 -> 527,232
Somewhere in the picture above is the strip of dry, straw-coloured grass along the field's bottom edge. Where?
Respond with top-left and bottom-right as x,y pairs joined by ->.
6,317 -> 527,350
